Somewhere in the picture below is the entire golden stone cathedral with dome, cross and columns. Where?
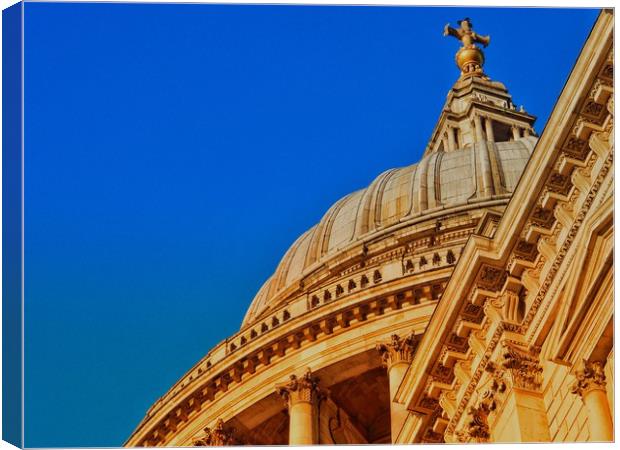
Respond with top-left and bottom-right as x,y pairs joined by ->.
125,10 -> 614,446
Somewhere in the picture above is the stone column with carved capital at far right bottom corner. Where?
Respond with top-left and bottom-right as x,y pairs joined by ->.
571,360 -> 614,442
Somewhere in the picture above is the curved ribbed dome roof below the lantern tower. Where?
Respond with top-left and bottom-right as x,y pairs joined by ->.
243,136 -> 536,325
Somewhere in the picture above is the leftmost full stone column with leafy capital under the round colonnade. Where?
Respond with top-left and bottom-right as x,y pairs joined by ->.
276,368 -> 319,445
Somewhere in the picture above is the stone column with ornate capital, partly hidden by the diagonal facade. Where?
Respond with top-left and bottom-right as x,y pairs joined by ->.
377,333 -> 418,443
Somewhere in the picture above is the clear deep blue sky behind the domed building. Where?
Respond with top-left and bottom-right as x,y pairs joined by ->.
25,3 -> 598,447
